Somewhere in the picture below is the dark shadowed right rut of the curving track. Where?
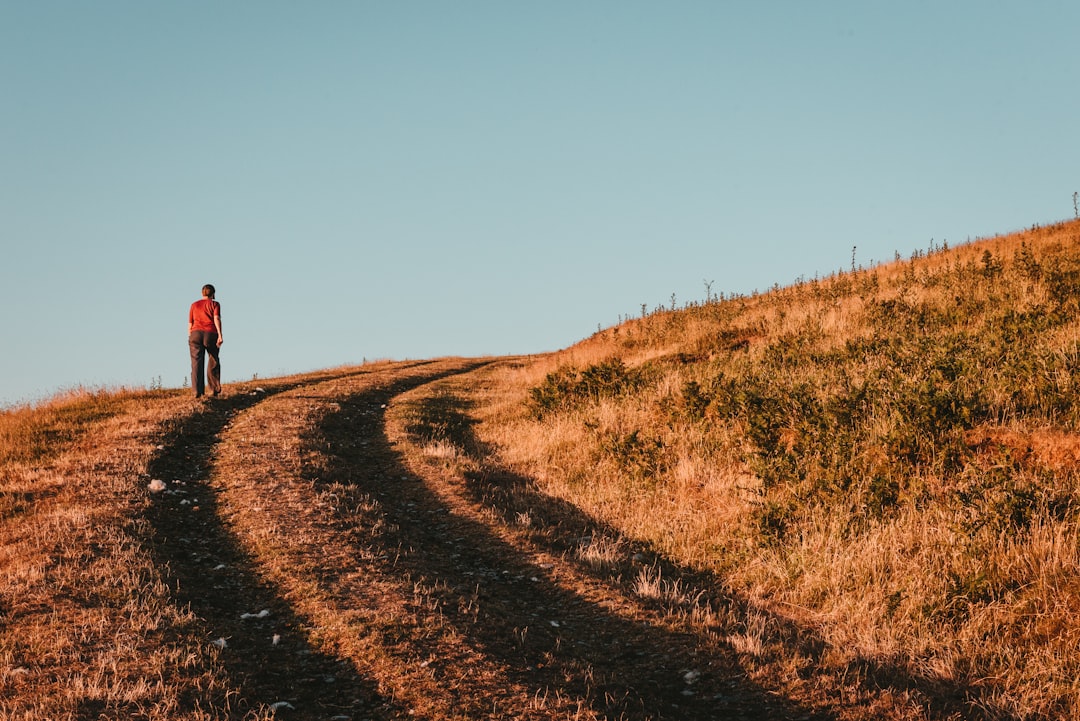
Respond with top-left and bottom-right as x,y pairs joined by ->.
312,381 -> 833,721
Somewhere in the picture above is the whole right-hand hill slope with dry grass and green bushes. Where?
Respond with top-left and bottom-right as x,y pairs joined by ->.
470,222 -> 1080,719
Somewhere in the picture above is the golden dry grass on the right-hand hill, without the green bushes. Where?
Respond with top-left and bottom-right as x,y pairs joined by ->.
480,222 -> 1080,719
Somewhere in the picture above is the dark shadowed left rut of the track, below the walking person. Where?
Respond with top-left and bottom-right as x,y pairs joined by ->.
147,380 -> 408,719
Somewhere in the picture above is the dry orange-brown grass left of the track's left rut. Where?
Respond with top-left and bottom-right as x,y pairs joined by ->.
0,391 -> 246,720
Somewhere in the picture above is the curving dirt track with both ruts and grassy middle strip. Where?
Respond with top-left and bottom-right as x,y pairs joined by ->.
139,361 -> 829,721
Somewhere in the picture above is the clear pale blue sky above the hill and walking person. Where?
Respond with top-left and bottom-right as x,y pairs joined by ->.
0,0 -> 1080,405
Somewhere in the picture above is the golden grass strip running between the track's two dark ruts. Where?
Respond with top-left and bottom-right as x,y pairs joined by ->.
203,359 -> 630,721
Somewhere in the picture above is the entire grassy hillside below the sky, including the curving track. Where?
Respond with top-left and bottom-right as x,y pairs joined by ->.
0,223 -> 1080,721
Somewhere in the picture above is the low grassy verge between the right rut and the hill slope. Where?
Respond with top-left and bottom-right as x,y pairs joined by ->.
392,373 -> 993,720
